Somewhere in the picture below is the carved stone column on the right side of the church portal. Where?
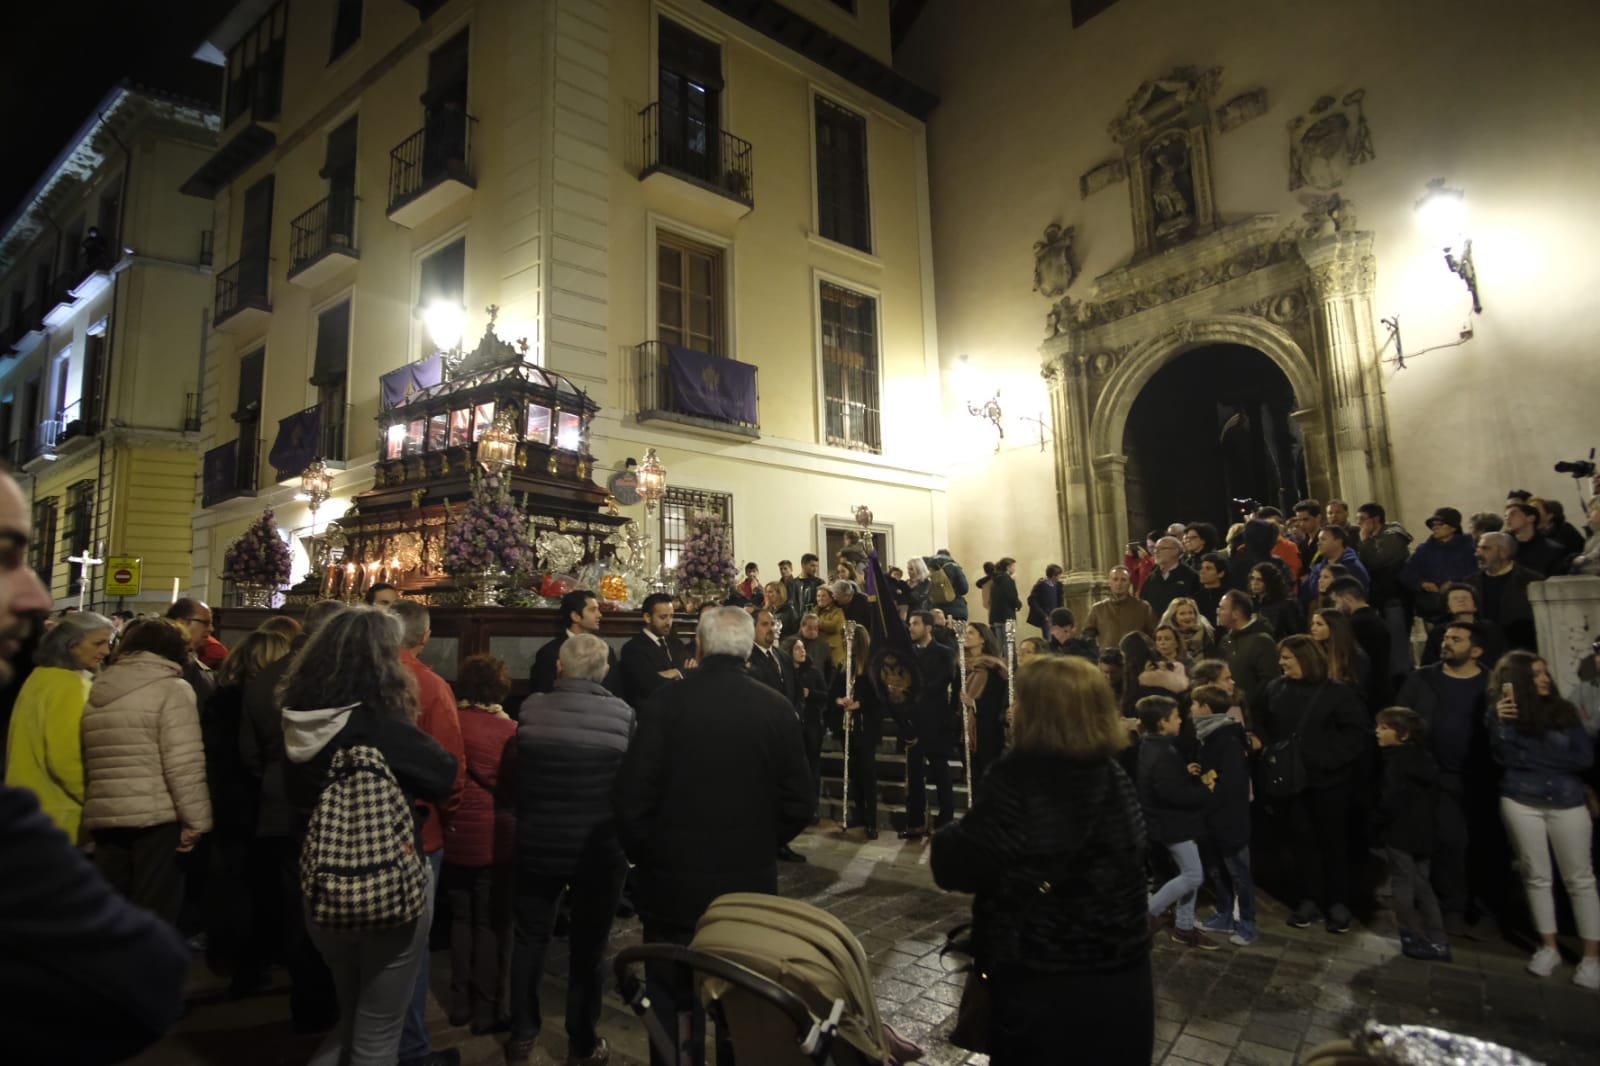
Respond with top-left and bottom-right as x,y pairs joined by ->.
1299,234 -> 1398,511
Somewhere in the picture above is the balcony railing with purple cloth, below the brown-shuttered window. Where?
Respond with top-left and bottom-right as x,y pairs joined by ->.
634,341 -> 762,437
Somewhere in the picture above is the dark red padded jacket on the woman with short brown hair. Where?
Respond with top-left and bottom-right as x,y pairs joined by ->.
445,704 -> 517,866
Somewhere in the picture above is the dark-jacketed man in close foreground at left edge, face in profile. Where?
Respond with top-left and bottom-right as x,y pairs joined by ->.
0,472 -> 189,1063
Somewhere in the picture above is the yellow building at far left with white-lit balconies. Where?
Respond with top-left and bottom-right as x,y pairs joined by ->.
0,80 -> 219,610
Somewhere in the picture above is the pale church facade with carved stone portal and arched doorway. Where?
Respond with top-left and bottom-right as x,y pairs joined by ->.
896,0 -> 1600,602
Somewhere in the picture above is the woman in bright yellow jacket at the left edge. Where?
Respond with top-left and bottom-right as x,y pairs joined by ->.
5,611 -> 112,844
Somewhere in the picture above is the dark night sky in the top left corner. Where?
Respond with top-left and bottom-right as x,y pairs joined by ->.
0,0 -> 230,219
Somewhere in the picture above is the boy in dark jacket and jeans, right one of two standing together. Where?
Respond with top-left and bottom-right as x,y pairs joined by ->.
1189,685 -> 1256,948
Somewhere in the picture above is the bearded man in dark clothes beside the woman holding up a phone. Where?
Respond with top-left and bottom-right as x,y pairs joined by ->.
1397,621 -> 1504,936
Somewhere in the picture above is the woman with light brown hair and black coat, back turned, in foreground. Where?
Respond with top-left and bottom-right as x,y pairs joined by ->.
931,655 -> 1155,1066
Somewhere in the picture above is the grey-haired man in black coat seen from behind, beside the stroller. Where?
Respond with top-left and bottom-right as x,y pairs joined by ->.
611,607 -> 813,1063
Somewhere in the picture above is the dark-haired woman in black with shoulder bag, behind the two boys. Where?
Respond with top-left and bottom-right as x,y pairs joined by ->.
1251,634 -> 1373,933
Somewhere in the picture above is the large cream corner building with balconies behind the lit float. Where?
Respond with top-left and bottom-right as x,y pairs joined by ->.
182,0 -> 946,597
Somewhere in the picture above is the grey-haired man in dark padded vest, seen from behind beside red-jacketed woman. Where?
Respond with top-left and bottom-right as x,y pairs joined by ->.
506,633 -> 636,1063
